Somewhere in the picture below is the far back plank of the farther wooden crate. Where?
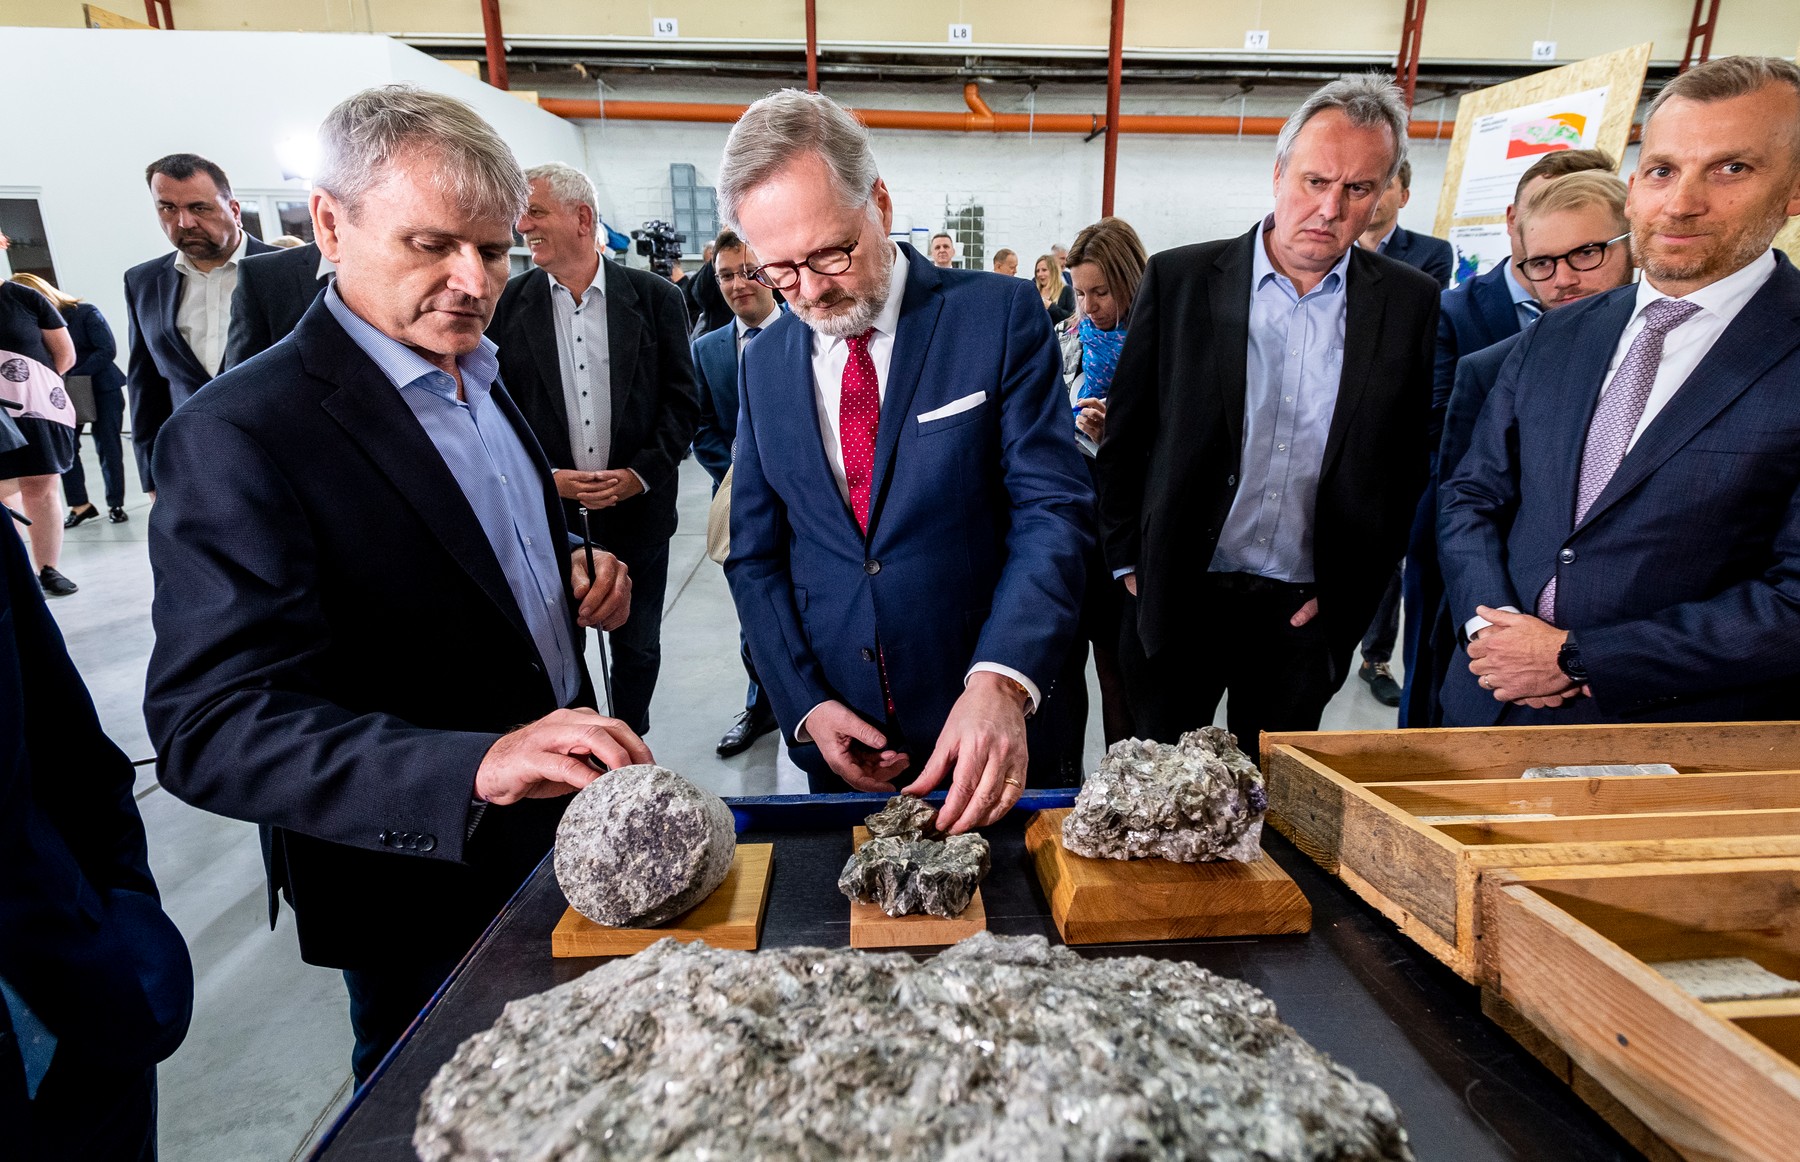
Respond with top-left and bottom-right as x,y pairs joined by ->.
1262,721 -> 1800,782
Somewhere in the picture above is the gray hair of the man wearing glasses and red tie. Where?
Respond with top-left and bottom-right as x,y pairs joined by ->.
718,88 -> 880,228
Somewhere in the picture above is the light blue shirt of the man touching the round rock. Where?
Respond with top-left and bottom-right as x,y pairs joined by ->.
326,282 -> 581,705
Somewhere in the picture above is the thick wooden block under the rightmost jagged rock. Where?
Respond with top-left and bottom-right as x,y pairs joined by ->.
1024,808 -> 1312,944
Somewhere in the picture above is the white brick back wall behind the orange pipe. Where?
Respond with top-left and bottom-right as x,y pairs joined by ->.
576,79 -> 1456,264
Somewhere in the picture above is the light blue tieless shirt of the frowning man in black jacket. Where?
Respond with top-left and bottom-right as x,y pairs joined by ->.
1210,227 -> 1350,585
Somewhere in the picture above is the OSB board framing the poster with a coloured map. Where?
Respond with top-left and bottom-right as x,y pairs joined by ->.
1431,41 -> 1652,237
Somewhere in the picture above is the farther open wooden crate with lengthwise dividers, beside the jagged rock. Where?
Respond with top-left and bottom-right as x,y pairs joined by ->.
1262,721 -> 1800,982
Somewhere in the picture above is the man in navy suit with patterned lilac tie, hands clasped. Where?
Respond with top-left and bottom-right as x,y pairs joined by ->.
1438,58 -> 1800,725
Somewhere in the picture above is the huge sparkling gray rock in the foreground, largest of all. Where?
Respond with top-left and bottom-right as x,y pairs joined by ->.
412,932 -> 1411,1162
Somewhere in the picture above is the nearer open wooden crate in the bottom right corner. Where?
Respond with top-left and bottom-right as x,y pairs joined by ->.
1481,858 -> 1800,1162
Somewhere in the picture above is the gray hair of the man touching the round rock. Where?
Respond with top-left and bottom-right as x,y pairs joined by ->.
313,85 -> 529,221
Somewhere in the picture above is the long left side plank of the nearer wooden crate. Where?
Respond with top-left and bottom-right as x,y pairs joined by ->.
1483,874 -> 1800,1162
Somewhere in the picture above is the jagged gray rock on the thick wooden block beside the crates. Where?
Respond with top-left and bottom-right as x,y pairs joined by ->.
1062,727 -> 1269,863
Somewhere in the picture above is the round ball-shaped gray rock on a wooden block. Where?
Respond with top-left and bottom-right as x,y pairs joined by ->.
556,764 -> 738,928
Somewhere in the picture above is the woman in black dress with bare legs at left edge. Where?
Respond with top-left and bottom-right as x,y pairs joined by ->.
0,251 -> 76,597
